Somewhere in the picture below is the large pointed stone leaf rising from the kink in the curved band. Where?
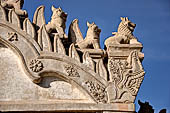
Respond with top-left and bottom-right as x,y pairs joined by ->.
38,25 -> 52,52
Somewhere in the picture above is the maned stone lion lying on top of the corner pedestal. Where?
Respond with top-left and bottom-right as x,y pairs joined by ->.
105,17 -> 139,47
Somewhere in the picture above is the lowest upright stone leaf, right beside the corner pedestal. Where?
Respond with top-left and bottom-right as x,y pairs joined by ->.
96,59 -> 107,81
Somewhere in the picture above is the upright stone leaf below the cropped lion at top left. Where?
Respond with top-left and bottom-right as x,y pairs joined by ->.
8,10 -> 21,28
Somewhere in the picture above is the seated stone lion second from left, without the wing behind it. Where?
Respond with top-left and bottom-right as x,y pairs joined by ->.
46,6 -> 67,38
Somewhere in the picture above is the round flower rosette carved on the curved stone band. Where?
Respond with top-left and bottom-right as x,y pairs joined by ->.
29,59 -> 44,72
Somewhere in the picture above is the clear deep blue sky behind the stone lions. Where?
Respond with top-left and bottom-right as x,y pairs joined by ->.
23,0 -> 170,112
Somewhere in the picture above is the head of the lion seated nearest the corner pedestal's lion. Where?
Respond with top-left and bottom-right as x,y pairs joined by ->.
86,22 -> 101,39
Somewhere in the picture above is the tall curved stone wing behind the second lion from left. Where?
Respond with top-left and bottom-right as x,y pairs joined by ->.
33,6 -> 45,30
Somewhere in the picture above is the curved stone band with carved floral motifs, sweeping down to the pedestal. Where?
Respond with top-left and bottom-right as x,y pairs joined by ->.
0,21 -> 108,103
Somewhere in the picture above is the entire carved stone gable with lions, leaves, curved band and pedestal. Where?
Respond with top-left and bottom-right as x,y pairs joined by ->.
0,0 -> 145,113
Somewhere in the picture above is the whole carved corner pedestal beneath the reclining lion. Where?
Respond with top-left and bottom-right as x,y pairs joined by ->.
107,44 -> 145,103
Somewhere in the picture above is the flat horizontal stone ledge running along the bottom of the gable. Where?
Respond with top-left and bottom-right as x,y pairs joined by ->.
0,101 -> 135,112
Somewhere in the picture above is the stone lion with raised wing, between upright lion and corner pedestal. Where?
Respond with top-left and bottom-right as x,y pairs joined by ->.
69,19 -> 101,49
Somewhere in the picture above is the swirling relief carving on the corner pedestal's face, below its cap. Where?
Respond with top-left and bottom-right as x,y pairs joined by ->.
108,51 -> 145,102
